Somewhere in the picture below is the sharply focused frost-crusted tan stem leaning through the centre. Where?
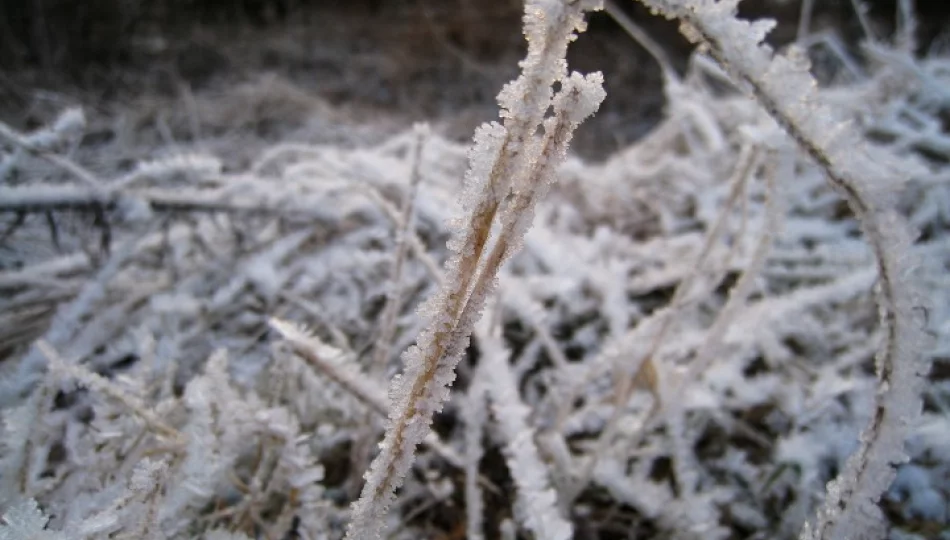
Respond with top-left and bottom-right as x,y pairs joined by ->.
347,0 -> 603,540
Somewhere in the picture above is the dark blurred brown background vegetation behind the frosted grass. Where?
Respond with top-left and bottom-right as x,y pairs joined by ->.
0,0 -> 950,158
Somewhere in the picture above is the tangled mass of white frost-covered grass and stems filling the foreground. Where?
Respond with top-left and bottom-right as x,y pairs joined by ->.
0,0 -> 950,540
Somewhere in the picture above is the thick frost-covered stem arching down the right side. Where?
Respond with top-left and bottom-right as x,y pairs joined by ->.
641,0 -> 927,539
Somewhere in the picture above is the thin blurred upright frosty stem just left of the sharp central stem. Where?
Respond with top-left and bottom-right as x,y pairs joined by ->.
372,126 -> 427,371
